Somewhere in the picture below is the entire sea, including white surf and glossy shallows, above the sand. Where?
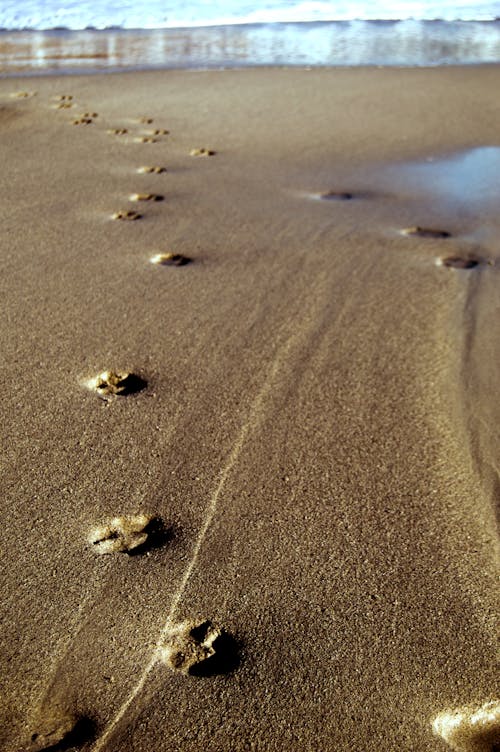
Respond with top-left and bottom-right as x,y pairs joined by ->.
0,0 -> 500,76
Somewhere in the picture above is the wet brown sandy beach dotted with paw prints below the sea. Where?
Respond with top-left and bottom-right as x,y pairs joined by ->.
0,66 -> 500,752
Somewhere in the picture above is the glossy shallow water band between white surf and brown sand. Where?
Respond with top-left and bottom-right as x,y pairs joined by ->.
0,21 -> 500,75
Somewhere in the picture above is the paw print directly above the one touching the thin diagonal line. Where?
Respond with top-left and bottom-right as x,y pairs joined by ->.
88,514 -> 155,554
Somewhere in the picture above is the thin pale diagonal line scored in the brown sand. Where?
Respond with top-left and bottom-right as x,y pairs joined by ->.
93,354 -> 284,752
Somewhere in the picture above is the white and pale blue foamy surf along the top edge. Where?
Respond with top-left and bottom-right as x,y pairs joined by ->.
0,0 -> 500,30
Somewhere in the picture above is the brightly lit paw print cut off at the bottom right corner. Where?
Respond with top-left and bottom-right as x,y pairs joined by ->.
432,701 -> 500,752
